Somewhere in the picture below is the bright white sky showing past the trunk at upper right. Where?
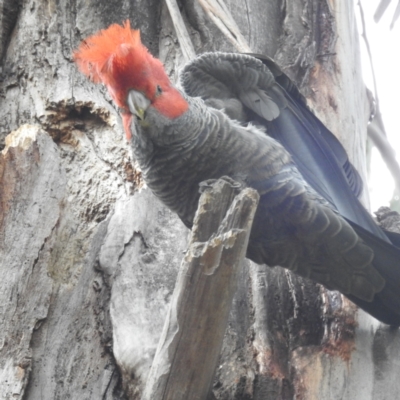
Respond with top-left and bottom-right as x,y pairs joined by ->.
356,0 -> 400,211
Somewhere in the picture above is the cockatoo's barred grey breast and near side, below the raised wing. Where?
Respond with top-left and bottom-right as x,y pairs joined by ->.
133,82 -> 384,301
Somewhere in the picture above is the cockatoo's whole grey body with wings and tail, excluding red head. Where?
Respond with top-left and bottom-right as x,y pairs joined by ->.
127,53 -> 400,324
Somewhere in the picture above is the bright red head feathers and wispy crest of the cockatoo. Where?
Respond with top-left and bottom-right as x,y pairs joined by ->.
74,21 -> 188,139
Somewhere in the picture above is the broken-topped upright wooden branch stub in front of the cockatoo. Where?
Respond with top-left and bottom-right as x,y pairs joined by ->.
143,179 -> 259,400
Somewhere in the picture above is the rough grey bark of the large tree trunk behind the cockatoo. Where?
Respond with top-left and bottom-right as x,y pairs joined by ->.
0,0 -> 400,400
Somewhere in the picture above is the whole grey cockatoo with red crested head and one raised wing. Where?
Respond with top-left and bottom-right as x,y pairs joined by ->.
73,21 -> 400,326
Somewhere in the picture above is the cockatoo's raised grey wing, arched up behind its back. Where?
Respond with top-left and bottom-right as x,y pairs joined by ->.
181,53 -> 360,206
